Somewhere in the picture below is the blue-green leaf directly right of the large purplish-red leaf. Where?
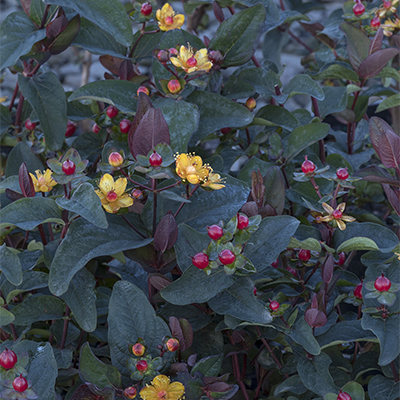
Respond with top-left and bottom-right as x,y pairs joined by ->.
153,98 -> 200,153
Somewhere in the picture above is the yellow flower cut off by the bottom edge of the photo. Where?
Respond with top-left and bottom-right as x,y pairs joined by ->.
140,375 -> 185,400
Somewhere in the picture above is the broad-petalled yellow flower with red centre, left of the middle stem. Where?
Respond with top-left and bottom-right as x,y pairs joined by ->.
95,174 -> 133,214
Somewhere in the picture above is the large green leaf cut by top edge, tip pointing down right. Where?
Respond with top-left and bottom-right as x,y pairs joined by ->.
45,0 -> 133,47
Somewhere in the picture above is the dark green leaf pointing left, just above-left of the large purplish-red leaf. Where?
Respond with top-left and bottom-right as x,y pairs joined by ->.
68,80 -> 139,112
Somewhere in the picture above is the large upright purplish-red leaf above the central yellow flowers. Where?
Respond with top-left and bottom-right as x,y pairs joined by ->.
128,106 -> 170,157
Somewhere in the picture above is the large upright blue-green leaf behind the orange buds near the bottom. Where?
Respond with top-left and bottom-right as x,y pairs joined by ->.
108,281 -> 170,377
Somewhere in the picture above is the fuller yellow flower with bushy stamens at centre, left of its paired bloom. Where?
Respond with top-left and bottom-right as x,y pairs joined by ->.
175,153 -> 211,185
